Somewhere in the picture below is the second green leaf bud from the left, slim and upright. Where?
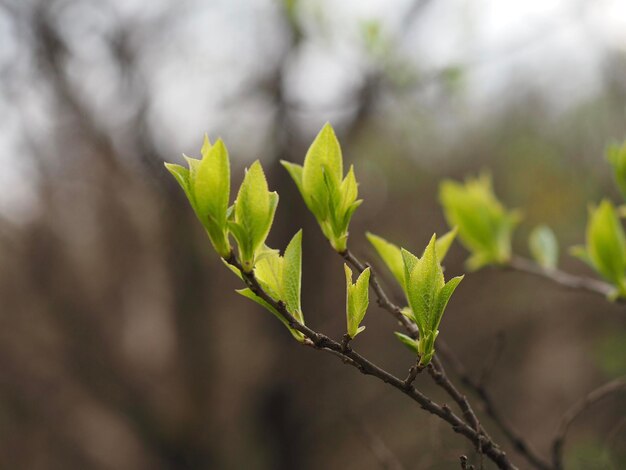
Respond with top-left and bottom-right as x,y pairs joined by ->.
228,160 -> 278,272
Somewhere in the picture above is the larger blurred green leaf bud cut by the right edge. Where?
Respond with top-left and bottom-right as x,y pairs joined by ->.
571,199 -> 626,298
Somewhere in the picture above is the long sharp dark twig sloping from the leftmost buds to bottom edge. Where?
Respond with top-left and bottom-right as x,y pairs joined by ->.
225,254 -> 517,470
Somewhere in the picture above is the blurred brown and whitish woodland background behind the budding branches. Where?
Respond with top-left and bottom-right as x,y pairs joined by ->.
0,0 -> 626,470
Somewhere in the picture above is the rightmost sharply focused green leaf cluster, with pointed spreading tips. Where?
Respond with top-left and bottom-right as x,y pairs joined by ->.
401,235 -> 463,365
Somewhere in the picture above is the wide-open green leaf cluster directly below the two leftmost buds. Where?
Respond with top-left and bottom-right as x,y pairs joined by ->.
228,230 -> 304,341
